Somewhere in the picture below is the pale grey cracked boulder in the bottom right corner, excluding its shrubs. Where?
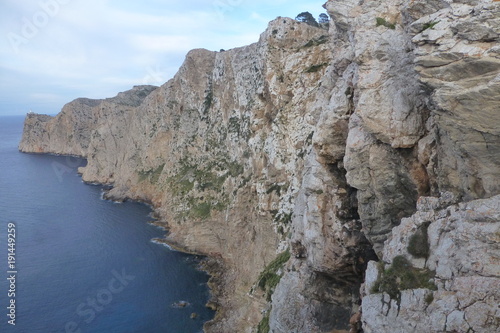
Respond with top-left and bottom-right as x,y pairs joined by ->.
362,195 -> 500,332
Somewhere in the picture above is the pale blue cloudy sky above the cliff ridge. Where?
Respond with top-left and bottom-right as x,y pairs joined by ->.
0,0 -> 326,116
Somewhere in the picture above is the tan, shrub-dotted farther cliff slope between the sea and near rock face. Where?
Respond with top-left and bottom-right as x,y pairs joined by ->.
20,18 -> 340,332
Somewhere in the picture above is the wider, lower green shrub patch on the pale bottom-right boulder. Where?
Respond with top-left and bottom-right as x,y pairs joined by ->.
372,256 -> 436,301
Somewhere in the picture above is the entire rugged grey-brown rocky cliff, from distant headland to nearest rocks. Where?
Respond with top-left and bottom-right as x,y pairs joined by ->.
20,0 -> 500,332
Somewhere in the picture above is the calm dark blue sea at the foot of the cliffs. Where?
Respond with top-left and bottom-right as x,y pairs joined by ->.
0,117 -> 213,333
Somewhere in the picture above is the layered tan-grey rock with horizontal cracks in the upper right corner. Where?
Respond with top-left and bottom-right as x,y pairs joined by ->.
411,1 -> 500,200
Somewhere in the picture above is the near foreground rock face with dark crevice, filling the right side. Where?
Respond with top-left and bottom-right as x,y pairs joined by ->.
270,0 -> 500,332
